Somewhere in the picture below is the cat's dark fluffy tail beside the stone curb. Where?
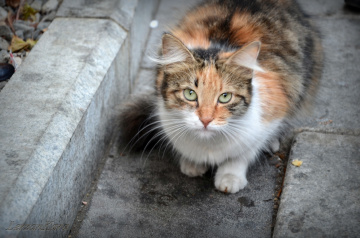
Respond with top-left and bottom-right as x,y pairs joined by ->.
119,95 -> 161,151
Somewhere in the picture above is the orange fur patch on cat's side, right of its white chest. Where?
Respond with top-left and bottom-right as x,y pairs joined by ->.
255,72 -> 289,122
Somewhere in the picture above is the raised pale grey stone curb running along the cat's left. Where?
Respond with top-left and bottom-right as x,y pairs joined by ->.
0,0 -> 157,237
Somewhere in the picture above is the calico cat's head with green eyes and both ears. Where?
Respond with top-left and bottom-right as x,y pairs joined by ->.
157,34 -> 262,137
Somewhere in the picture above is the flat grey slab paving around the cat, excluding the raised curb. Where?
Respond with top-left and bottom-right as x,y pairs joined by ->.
70,0 -> 360,237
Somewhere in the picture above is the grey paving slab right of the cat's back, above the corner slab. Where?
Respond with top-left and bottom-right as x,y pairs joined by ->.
297,19 -> 360,131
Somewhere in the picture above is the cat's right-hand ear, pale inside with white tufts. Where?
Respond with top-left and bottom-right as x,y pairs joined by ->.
225,41 -> 264,72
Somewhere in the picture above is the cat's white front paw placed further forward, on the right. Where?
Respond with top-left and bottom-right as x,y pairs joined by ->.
215,174 -> 247,193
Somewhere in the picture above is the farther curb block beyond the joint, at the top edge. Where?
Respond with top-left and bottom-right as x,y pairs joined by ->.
57,0 -> 159,91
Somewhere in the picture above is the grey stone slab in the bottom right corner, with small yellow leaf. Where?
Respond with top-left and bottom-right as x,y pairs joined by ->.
274,132 -> 360,238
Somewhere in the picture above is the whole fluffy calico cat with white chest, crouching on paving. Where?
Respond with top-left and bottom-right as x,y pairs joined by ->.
121,0 -> 322,193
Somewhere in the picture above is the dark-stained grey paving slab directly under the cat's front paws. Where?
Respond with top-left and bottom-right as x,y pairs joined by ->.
77,143 -> 277,237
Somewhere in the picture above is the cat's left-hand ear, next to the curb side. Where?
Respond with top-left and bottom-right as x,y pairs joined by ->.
161,33 -> 195,65
